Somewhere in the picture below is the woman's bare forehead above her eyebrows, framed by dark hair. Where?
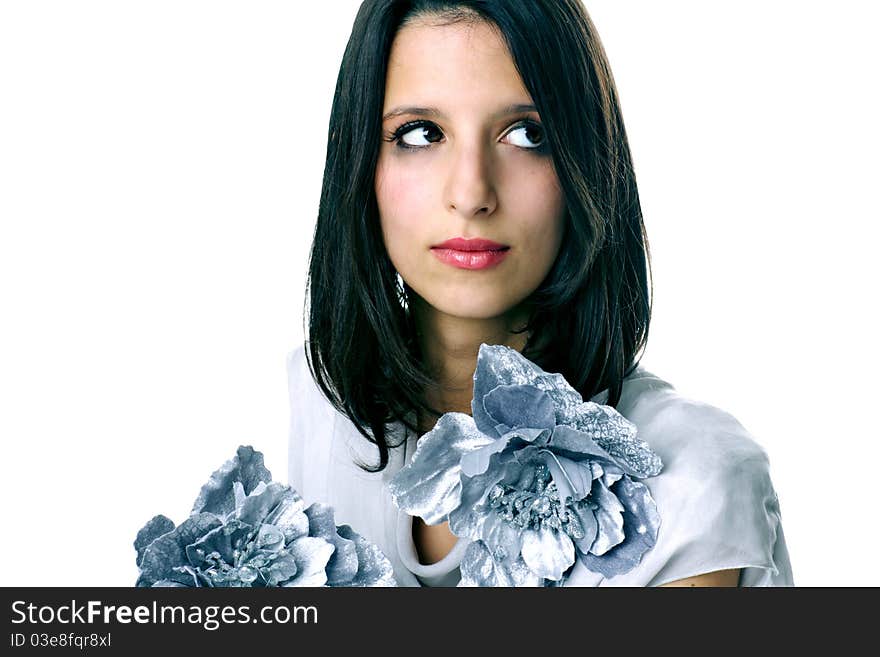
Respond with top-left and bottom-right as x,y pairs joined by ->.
385,19 -> 530,108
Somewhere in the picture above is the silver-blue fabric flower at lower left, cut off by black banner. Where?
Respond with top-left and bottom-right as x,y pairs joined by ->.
134,447 -> 396,587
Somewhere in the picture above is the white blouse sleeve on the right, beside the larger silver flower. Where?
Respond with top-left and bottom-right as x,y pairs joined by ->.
645,397 -> 793,586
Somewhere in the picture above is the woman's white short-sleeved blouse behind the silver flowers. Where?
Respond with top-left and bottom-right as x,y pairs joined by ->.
287,346 -> 794,586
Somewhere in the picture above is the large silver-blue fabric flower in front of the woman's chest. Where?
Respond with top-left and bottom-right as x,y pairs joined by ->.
389,344 -> 662,586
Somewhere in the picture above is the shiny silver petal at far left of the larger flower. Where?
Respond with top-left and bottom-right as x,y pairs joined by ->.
388,413 -> 491,525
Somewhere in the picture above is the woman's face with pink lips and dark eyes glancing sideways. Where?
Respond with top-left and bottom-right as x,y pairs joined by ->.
375,17 -> 564,319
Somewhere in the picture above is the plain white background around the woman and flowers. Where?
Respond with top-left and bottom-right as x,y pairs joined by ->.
0,0 -> 880,586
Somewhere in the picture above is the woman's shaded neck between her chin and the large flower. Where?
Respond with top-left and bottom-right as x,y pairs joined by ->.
411,295 -> 528,428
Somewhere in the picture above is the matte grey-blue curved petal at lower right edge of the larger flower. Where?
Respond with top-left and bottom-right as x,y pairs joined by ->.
581,477 -> 660,577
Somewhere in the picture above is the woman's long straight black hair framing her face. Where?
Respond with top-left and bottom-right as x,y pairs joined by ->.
304,0 -> 651,472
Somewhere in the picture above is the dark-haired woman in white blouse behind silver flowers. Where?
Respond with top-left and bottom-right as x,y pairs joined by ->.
288,0 -> 792,586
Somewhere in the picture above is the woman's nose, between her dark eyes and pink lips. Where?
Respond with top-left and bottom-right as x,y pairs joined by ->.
446,144 -> 498,219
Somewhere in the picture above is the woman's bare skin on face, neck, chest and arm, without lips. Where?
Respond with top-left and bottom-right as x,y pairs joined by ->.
375,17 -> 736,586
